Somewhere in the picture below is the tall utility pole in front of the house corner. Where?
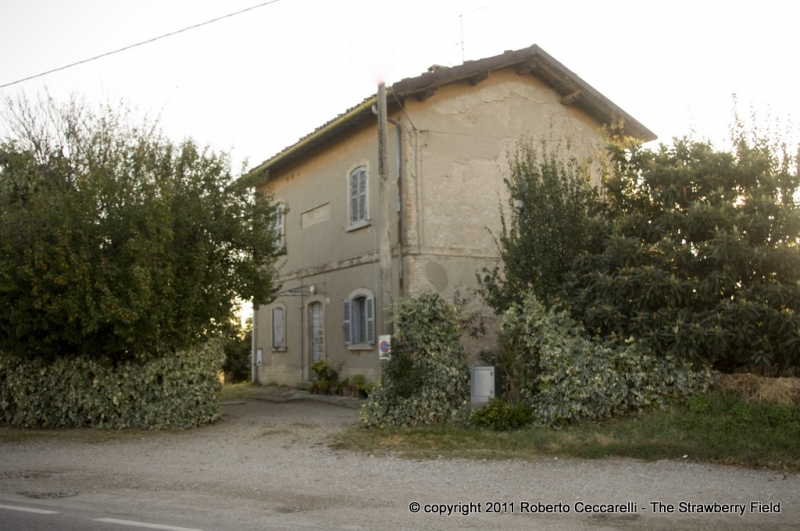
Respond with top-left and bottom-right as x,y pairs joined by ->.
378,83 -> 392,334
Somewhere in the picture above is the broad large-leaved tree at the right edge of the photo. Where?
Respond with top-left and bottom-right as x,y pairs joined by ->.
563,133 -> 800,371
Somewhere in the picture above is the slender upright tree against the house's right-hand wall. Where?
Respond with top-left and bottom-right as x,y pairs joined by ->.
478,142 -> 597,314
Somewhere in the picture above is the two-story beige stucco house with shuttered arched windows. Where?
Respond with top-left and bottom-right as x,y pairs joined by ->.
242,45 -> 656,385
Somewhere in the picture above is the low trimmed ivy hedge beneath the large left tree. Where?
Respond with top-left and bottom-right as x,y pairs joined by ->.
0,340 -> 224,429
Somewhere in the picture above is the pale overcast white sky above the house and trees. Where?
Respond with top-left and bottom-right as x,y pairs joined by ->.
0,0 -> 800,176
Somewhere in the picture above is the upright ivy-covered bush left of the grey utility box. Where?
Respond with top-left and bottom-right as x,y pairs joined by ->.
359,293 -> 469,427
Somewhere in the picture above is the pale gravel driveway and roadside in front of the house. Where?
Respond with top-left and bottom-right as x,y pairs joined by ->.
0,400 -> 800,530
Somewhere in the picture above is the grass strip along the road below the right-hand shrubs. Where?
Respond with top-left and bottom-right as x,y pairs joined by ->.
332,394 -> 800,471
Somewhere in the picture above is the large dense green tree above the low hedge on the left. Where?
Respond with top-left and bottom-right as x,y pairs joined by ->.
0,97 -> 282,361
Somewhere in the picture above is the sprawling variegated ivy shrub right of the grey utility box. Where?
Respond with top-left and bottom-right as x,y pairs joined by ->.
501,294 -> 711,426
